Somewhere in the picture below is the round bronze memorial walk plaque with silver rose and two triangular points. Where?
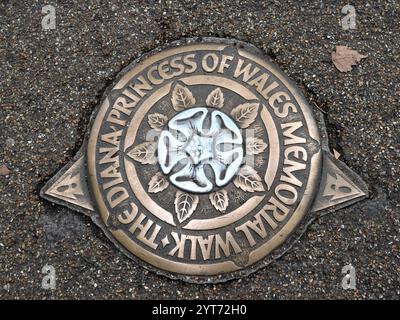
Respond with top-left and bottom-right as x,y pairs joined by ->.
41,38 -> 367,282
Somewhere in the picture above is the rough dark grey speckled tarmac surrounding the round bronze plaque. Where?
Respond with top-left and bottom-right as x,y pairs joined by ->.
0,0 -> 400,299
